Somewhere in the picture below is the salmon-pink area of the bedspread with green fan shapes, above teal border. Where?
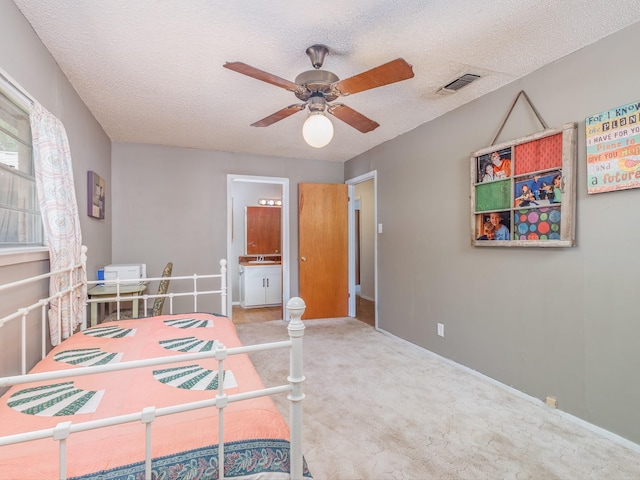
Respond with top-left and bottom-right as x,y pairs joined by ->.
0,314 -> 289,480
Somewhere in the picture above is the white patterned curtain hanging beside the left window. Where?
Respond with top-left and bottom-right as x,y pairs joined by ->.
30,102 -> 87,345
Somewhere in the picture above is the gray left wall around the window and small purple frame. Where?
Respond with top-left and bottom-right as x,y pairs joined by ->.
0,1 -> 112,375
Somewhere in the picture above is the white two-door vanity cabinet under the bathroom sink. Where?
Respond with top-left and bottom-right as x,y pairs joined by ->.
240,264 -> 282,308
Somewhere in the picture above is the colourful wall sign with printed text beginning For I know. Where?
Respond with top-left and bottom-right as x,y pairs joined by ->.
585,102 -> 640,193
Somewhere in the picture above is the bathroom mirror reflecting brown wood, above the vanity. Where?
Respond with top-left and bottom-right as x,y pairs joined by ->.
244,206 -> 282,255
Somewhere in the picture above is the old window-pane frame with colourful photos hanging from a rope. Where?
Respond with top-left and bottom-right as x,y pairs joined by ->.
471,123 -> 577,247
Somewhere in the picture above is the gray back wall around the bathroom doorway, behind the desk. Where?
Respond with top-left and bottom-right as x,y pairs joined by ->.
111,143 -> 343,311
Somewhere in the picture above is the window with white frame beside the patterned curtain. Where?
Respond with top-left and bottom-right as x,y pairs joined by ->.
0,82 -> 43,248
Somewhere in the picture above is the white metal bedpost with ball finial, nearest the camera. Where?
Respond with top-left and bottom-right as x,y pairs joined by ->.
287,297 -> 307,479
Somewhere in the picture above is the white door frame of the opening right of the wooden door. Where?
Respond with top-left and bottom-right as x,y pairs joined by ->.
344,170 -> 380,330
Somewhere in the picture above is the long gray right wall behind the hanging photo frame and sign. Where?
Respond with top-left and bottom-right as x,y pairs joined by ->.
345,24 -> 640,443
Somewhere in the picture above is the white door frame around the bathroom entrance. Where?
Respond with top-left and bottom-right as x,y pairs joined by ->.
227,173 -> 291,319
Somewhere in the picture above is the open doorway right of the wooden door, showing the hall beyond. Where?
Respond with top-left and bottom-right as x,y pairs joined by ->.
345,170 -> 380,329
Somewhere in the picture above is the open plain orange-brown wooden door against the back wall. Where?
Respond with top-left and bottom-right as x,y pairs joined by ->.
298,183 -> 349,319
